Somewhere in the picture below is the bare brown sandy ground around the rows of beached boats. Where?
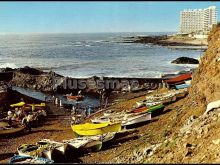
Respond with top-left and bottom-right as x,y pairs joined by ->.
0,88 -> 181,163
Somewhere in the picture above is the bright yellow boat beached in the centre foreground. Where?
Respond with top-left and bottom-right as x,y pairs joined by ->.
71,122 -> 121,136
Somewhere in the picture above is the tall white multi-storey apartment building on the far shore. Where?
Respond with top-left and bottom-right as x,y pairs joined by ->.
180,6 -> 217,33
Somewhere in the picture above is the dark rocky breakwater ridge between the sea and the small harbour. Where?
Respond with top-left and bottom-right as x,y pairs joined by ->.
0,67 -> 163,94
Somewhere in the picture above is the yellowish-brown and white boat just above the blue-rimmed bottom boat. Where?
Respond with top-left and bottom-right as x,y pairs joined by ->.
17,144 -> 43,157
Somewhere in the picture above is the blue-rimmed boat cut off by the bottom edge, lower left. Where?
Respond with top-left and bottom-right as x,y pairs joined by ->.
9,155 -> 54,164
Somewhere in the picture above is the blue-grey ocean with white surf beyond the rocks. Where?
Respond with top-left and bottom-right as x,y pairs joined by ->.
0,33 -> 202,78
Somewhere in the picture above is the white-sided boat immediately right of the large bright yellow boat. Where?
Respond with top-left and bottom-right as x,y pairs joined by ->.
122,113 -> 151,126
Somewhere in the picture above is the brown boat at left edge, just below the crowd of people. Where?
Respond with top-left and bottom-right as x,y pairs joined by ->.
0,122 -> 25,135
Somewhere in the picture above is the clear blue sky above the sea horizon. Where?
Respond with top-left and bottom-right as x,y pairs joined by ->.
0,1 -> 220,34
